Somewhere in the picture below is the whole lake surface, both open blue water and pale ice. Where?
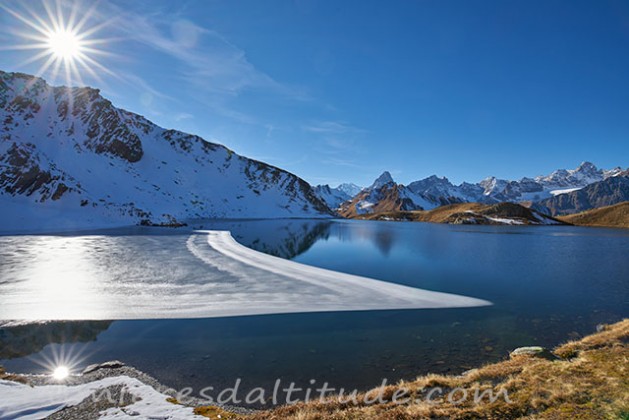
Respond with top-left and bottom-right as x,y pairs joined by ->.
0,220 -> 629,406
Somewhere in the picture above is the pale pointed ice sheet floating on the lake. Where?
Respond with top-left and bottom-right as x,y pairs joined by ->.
0,231 -> 490,320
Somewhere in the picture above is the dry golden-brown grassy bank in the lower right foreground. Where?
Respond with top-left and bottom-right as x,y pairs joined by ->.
253,319 -> 629,420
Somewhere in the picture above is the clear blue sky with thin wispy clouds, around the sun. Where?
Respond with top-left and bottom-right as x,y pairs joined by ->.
0,0 -> 629,185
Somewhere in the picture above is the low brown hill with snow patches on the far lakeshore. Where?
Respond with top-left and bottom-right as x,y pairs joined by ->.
350,203 -> 564,225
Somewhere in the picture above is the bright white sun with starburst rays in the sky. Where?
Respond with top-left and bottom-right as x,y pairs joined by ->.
0,0 -> 115,86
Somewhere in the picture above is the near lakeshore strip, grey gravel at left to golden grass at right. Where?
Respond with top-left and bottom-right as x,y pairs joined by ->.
0,319 -> 629,419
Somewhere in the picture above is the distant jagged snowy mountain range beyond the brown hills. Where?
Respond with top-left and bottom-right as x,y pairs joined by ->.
332,162 -> 626,217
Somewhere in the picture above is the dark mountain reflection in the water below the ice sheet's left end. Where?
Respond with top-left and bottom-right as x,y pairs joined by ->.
0,321 -> 111,359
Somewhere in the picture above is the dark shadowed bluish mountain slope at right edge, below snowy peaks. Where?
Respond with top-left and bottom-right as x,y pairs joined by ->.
533,171 -> 629,215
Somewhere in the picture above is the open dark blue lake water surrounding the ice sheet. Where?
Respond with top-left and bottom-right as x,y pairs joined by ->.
0,220 -> 629,406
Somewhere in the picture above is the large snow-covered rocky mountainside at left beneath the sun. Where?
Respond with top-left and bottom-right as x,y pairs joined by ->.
0,71 -> 330,229
